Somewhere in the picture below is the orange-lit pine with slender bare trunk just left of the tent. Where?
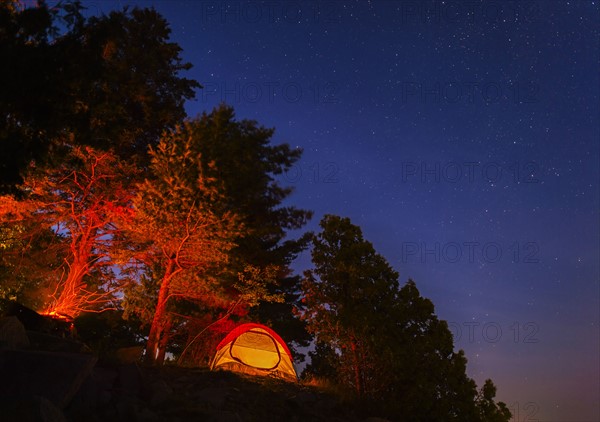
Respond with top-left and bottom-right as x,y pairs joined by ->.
119,132 -> 241,361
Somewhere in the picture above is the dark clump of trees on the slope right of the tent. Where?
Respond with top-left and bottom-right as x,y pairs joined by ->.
303,215 -> 510,422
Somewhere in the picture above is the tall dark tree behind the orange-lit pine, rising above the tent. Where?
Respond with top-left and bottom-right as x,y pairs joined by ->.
138,105 -> 311,362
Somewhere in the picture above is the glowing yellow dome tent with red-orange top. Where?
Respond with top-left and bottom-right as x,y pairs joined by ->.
210,324 -> 298,381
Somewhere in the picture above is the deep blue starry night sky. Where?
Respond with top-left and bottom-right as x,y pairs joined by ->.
78,1 -> 600,422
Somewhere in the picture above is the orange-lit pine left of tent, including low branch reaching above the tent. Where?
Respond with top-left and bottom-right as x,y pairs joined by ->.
123,130 -> 288,362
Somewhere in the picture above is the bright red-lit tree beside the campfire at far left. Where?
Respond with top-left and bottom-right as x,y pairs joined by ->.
3,147 -> 137,317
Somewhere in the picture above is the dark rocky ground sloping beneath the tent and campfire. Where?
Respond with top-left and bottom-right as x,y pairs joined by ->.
0,306 -> 392,422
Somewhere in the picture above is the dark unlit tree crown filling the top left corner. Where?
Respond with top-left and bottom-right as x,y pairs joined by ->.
0,1 -> 200,192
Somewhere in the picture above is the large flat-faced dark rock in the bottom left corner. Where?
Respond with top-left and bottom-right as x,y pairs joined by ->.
0,350 -> 97,409
